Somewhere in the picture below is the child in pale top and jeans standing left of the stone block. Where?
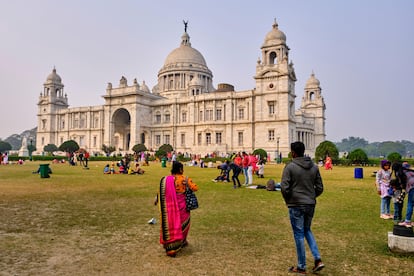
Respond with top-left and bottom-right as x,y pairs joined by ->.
375,160 -> 394,219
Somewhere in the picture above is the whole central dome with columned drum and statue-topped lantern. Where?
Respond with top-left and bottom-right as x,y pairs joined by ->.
157,22 -> 214,97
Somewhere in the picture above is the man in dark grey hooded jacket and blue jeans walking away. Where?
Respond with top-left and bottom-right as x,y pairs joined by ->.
281,142 -> 325,274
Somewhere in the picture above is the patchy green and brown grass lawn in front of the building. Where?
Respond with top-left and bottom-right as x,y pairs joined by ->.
0,162 -> 414,275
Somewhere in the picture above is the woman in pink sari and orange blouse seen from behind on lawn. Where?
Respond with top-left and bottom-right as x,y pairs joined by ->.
158,162 -> 198,257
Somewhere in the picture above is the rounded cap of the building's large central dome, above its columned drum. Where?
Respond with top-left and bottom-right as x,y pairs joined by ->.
164,33 -> 207,66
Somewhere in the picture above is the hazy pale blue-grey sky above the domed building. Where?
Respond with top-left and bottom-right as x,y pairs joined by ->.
0,0 -> 414,142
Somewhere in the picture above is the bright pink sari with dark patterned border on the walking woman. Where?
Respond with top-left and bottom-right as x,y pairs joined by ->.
158,175 -> 190,256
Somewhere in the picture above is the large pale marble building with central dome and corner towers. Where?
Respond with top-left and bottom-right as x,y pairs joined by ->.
36,22 -> 326,159
